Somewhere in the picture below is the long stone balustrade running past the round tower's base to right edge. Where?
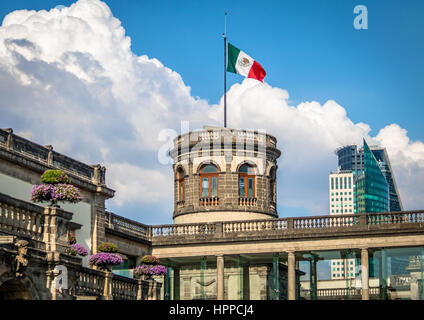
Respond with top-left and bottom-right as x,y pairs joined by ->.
148,211 -> 424,240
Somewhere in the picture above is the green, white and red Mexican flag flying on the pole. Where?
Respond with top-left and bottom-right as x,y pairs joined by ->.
227,43 -> 266,82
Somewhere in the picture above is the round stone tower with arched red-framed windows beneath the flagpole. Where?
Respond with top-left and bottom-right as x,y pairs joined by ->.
170,127 -> 281,223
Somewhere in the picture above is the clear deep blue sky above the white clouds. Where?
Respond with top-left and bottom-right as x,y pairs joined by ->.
0,0 -> 424,140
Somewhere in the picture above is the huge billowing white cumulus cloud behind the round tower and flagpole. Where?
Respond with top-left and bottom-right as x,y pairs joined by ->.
0,0 -> 424,223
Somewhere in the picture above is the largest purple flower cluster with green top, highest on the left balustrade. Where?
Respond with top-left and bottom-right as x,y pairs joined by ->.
31,170 -> 82,207
